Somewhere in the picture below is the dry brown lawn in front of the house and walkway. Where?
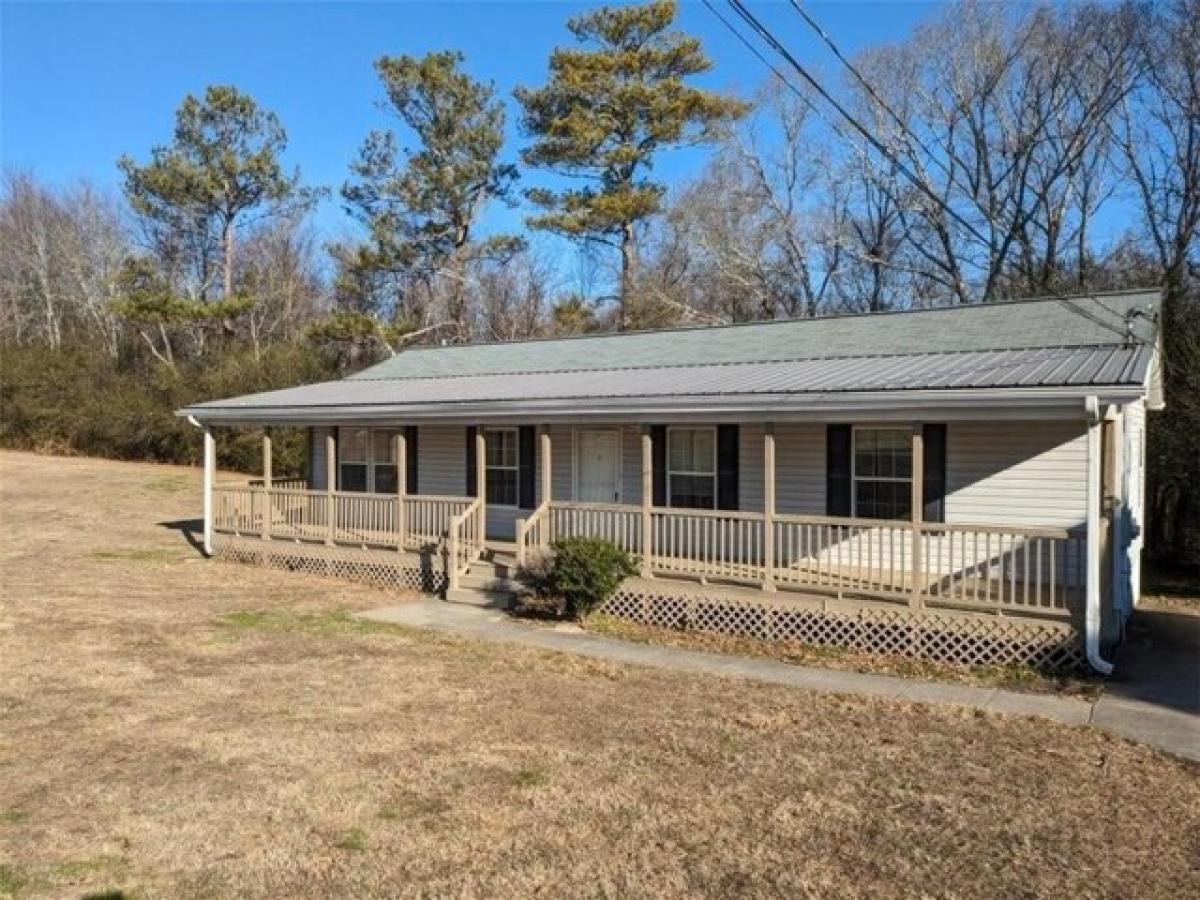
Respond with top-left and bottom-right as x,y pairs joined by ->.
0,454 -> 1200,898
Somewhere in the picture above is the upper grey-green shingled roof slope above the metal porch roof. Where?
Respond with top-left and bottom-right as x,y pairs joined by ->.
352,292 -> 1159,380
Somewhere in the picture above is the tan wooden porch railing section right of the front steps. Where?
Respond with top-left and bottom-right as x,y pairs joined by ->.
517,500 -> 1086,613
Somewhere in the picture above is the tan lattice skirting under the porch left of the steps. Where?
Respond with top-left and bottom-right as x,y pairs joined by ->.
212,534 -> 445,594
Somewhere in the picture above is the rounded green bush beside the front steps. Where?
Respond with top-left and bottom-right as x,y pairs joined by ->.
517,538 -> 637,618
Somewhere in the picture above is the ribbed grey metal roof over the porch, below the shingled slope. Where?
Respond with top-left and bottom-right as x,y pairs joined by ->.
179,344 -> 1153,424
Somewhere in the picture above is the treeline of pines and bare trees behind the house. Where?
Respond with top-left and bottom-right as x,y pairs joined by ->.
0,0 -> 1200,564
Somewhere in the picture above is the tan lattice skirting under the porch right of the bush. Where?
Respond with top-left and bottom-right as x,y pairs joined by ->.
602,581 -> 1085,671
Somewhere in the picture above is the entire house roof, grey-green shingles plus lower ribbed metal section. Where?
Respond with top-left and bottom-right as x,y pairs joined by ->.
179,293 -> 1158,422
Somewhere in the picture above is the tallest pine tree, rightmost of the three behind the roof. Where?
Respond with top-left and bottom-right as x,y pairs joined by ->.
516,0 -> 746,328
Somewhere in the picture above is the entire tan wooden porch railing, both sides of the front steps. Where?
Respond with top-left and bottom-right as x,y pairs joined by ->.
212,484 -> 1086,613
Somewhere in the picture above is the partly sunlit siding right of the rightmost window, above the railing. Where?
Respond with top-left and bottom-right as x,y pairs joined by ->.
946,421 -> 1087,528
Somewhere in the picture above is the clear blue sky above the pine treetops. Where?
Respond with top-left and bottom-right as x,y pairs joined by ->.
0,0 -> 932,244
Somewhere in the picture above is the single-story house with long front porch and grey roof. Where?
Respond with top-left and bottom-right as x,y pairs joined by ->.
179,292 -> 1162,672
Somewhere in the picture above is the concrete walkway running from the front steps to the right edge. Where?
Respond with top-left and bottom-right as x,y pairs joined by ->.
359,600 -> 1200,760
